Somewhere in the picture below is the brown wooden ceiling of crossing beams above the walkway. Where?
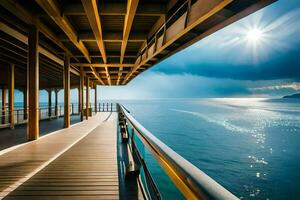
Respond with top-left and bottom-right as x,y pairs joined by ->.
0,0 -> 274,87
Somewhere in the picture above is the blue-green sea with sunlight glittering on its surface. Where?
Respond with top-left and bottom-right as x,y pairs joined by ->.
122,98 -> 300,199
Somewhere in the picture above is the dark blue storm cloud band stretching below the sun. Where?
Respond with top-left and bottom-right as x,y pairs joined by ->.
154,50 -> 300,80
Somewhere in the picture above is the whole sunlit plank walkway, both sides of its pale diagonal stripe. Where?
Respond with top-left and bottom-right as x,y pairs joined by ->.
0,113 -> 119,200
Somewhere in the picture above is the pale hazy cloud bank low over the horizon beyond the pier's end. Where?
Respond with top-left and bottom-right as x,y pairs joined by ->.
99,72 -> 255,99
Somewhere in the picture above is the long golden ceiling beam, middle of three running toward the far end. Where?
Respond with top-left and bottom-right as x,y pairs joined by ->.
81,0 -> 111,84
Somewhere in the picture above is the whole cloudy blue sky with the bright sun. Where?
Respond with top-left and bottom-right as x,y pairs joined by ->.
98,0 -> 300,99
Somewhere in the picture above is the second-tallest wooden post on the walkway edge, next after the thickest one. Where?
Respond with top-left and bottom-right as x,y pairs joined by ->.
64,54 -> 70,128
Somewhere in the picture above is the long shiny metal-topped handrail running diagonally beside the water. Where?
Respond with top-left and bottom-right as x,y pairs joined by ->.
118,104 -> 238,200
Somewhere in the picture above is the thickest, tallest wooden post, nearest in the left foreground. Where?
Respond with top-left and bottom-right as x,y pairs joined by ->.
27,25 -> 39,140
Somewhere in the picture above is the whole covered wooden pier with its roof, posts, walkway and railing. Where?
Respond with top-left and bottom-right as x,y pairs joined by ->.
0,0 -> 276,200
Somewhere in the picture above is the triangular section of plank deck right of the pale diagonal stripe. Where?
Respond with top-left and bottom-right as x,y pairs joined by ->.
3,113 -> 119,199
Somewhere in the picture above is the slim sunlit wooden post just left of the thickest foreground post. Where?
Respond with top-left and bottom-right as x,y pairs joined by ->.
9,64 -> 15,129
